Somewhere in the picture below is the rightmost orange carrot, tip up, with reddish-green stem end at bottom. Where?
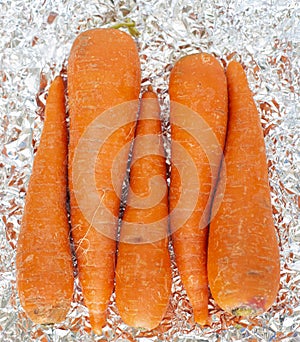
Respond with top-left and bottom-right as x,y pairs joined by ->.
208,61 -> 279,316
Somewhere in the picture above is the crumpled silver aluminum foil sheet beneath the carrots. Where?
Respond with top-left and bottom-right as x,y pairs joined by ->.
0,0 -> 300,342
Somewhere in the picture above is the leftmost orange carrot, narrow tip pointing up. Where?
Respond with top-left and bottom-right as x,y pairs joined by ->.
16,77 -> 74,324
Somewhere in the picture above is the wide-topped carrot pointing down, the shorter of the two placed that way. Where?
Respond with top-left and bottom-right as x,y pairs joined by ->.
169,53 -> 227,325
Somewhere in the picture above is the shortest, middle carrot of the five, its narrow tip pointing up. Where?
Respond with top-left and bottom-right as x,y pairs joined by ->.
116,91 -> 172,330
